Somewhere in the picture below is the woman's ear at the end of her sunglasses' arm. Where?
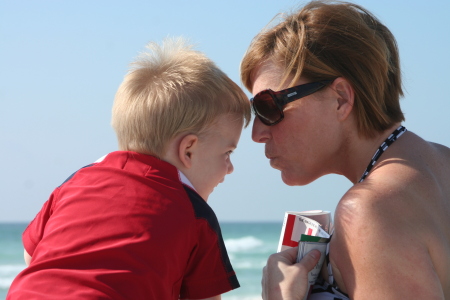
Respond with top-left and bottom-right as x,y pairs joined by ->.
331,77 -> 355,121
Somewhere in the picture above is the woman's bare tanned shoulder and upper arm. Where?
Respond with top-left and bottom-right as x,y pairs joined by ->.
330,177 -> 442,299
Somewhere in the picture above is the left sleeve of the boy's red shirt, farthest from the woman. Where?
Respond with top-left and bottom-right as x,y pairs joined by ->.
22,190 -> 58,256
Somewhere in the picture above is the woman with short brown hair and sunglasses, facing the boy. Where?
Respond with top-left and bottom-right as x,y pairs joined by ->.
241,1 -> 450,299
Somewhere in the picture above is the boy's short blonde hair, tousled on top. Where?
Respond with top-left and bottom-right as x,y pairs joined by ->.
112,38 -> 251,156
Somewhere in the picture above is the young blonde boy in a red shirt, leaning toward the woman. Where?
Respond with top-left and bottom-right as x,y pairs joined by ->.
7,39 -> 250,300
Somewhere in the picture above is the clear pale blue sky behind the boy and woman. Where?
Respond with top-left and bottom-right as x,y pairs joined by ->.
0,0 -> 450,222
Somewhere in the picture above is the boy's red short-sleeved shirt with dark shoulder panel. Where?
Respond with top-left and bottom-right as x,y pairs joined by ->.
7,151 -> 239,300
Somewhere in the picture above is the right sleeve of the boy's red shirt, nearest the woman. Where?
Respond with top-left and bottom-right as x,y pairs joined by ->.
180,219 -> 239,299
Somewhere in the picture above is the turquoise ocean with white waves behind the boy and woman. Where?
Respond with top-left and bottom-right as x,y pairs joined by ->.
0,222 -> 282,300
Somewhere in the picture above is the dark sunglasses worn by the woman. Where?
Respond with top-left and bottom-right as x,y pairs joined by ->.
250,80 -> 333,126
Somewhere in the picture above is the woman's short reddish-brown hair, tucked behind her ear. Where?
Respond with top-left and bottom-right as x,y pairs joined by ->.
241,1 -> 404,137
